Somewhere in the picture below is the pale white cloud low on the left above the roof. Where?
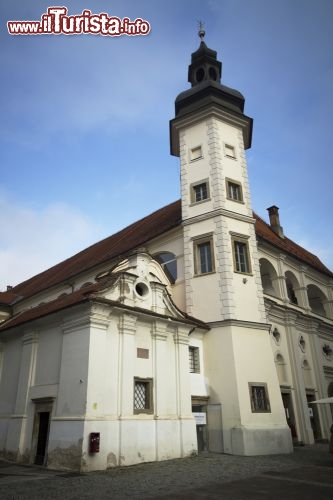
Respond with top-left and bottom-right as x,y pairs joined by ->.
0,192 -> 98,291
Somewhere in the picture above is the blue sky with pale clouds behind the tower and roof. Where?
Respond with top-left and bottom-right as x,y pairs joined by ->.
0,0 -> 333,291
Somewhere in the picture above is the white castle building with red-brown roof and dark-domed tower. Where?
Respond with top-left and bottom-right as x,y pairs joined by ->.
0,36 -> 333,471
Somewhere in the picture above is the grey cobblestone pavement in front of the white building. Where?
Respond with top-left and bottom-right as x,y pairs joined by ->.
0,444 -> 333,500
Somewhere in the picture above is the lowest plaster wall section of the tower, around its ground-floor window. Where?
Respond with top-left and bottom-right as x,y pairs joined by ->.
205,326 -> 292,455
